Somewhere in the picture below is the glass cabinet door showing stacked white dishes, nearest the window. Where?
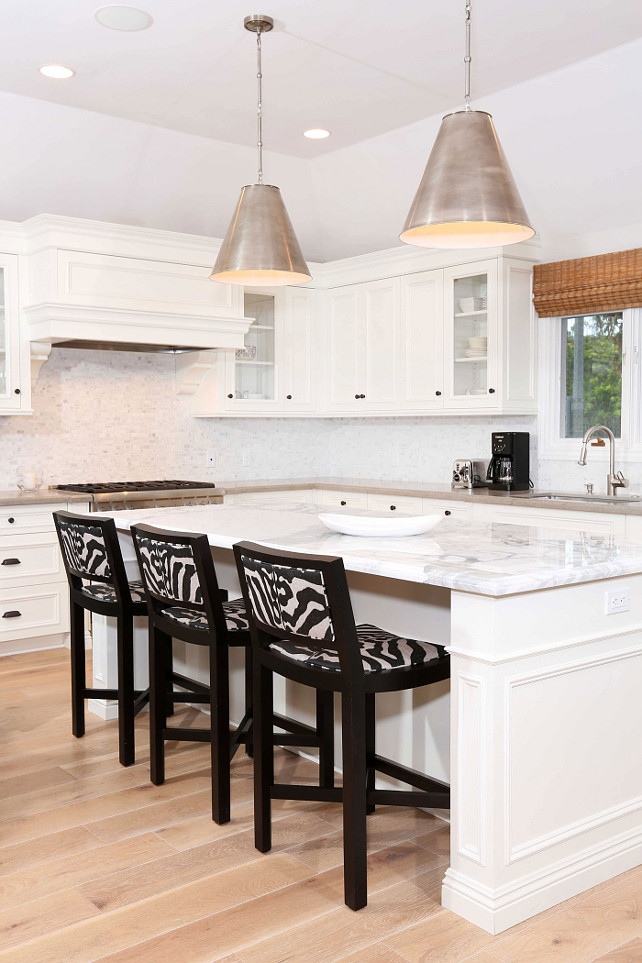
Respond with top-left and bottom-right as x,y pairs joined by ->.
446,262 -> 497,407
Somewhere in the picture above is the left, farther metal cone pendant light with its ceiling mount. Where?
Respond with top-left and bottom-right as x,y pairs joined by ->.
210,14 -> 312,285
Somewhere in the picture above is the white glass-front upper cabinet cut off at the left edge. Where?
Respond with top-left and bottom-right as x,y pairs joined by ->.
0,254 -> 30,415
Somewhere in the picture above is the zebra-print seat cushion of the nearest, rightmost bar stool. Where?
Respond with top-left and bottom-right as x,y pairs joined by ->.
269,625 -> 444,672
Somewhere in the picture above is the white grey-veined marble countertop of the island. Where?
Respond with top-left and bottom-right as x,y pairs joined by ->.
106,501 -> 642,596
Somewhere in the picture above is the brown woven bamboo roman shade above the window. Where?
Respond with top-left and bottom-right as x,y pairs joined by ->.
533,247 -> 642,318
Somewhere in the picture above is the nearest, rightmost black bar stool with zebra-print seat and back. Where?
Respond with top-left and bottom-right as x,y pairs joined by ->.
234,542 -> 450,910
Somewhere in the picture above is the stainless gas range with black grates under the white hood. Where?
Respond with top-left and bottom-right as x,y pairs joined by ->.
53,478 -> 223,512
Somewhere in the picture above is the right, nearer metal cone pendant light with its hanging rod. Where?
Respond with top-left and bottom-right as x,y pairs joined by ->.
399,0 -> 535,248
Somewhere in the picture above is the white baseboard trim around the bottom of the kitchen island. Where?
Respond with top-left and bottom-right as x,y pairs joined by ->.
441,829 -> 642,935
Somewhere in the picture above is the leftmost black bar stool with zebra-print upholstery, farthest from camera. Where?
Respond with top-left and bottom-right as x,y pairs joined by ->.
53,512 -> 149,766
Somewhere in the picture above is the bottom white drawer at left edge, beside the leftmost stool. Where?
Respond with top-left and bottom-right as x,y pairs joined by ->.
0,582 -> 69,651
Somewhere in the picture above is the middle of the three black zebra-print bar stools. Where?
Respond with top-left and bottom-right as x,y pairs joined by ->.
131,525 -> 334,823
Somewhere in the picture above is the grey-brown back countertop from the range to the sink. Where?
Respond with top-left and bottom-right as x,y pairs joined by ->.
216,477 -> 642,515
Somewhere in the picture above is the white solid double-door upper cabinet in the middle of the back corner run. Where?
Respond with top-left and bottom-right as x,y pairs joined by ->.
325,278 -> 400,413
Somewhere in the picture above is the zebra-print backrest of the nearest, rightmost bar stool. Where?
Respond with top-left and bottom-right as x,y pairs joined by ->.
234,542 -> 361,671
